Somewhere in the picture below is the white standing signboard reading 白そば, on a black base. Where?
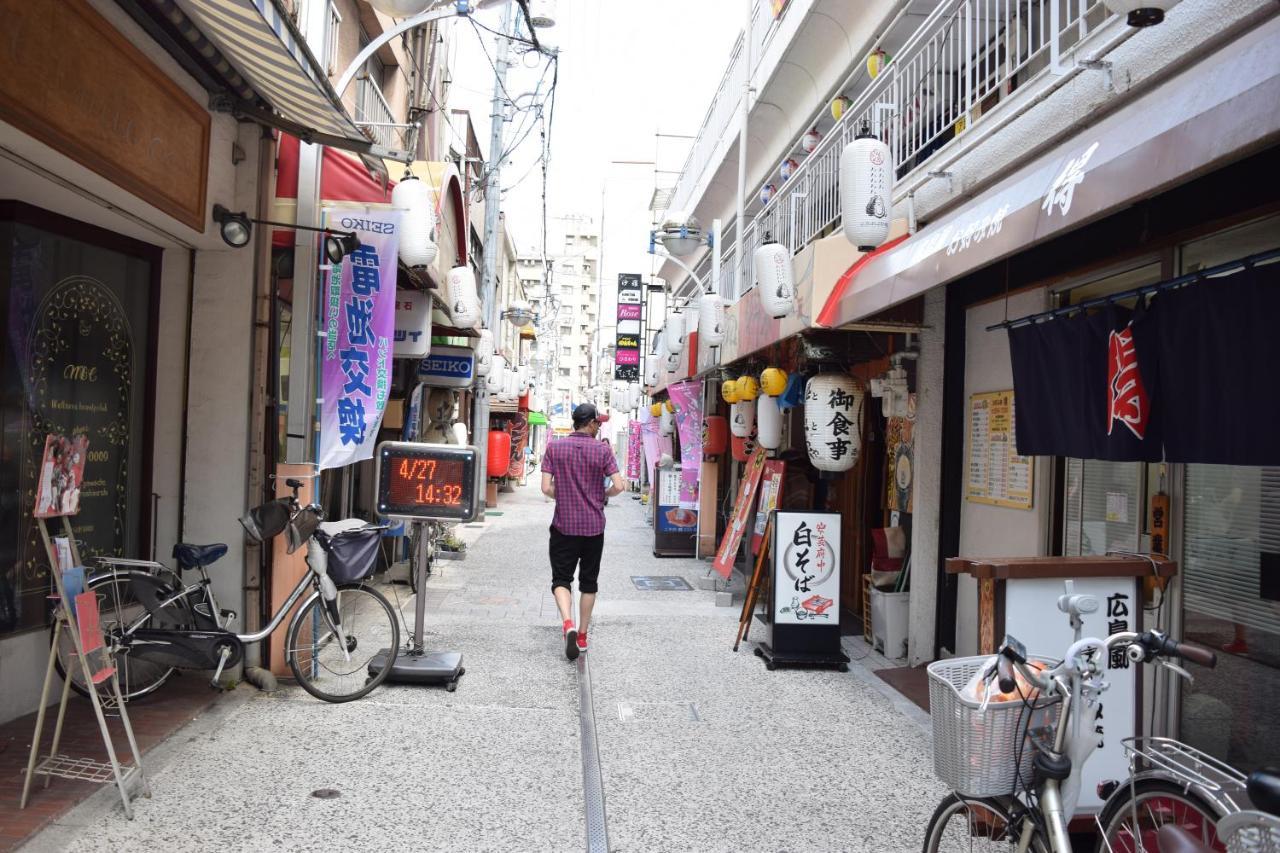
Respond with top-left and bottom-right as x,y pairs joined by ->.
773,511 -> 840,625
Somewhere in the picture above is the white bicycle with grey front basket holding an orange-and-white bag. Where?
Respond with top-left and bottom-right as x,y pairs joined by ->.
924,581 -> 1217,853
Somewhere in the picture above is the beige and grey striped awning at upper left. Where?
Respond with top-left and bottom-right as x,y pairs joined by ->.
161,0 -> 404,160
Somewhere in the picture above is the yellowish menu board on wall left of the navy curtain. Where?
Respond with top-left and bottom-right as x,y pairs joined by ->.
965,391 -> 1034,510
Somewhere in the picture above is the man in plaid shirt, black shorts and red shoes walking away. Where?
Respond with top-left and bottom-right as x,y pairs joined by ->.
543,403 -> 622,661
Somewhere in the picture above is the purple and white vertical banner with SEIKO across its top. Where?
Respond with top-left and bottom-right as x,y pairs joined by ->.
319,209 -> 401,469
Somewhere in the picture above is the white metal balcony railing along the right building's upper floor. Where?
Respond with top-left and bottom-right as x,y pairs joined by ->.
680,0 -> 1110,300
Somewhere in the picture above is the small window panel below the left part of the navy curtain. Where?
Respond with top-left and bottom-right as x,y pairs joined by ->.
1062,459 -> 1143,557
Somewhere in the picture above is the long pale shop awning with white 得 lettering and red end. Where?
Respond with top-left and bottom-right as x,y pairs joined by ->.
818,19 -> 1280,327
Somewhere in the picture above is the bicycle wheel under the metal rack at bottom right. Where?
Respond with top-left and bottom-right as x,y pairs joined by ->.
1096,779 -> 1226,853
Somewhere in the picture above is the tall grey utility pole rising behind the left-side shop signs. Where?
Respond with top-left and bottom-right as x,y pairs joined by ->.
471,3 -> 518,501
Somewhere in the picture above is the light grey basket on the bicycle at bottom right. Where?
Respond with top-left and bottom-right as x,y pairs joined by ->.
928,654 -> 1057,797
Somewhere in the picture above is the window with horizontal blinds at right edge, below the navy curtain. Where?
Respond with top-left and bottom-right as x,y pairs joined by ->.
1183,465 -> 1280,634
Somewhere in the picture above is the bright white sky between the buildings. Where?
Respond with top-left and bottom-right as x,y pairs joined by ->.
451,0 -> 745,298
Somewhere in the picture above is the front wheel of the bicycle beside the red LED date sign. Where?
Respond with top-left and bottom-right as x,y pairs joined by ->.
284,584 -> 399,702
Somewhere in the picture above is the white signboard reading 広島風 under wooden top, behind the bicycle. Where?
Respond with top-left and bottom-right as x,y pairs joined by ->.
1005,578 -> 1142,812
